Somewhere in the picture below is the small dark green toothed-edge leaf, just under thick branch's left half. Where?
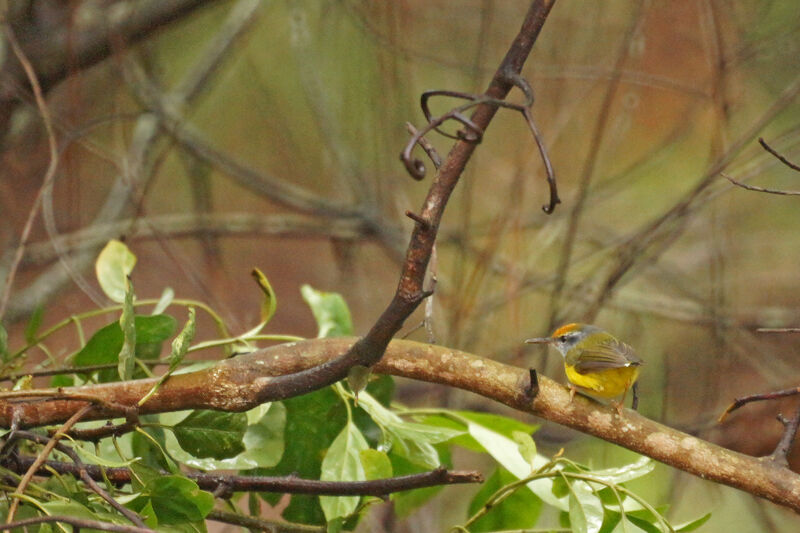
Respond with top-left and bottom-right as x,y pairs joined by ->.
172,409 -> 247,459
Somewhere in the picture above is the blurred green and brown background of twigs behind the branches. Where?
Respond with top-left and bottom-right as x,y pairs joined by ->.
0,0 -> 800,531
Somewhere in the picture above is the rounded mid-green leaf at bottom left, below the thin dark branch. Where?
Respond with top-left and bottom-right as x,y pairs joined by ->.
143,475 -> 214,525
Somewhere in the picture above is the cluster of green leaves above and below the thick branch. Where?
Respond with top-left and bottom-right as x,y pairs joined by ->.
0,241 -> 708,533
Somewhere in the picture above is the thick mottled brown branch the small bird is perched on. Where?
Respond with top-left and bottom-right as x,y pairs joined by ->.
0,338 -> 800,512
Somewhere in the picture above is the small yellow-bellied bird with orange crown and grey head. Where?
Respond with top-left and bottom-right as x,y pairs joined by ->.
525,323 -> 642,414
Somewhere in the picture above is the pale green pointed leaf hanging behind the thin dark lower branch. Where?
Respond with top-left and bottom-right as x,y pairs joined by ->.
319,423 -> 369,522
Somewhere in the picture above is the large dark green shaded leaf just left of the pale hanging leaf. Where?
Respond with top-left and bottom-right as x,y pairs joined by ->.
254,387 -> 347,525
